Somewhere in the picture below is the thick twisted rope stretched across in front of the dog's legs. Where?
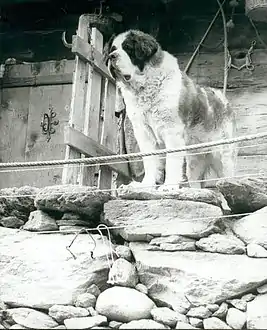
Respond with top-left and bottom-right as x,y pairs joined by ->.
0,132 -> 267,169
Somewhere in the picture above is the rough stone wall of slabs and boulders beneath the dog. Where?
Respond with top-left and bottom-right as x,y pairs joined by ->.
0,182 -> 267,329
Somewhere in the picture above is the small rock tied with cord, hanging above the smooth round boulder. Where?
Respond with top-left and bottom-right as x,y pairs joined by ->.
108,258 -> 138,288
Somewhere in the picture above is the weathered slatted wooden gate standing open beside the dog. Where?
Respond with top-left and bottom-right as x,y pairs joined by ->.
62,14 -> 131,189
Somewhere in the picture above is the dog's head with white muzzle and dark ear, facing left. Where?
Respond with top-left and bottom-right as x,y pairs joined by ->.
106,30 -> 162,82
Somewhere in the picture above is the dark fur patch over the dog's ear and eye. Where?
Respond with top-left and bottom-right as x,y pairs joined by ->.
122,30 -> 159,71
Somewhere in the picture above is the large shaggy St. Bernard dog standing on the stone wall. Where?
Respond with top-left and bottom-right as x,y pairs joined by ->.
107,30 -> 235,190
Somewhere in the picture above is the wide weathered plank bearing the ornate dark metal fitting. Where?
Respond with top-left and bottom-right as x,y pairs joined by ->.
23,85 -> 71,187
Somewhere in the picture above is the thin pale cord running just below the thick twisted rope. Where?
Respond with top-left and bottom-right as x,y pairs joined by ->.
0,143 -> 267,173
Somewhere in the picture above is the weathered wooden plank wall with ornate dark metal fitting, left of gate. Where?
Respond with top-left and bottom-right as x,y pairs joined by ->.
0,60 -> 73,188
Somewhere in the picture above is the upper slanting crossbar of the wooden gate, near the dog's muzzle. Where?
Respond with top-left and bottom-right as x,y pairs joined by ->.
72,36 -> 114,82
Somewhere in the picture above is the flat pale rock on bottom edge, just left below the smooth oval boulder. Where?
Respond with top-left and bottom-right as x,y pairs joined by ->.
64,315 -> 107,329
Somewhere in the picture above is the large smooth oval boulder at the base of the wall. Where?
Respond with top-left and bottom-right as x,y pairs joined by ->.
96,286 -> 155,322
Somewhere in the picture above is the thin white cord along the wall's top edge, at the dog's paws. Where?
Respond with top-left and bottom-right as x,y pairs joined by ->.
0,171 -> 267,200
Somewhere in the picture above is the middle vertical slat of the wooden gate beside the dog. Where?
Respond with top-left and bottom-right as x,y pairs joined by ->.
81,28 -> 103,186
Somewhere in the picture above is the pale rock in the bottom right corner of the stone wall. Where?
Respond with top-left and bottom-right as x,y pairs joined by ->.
247,294 -> 267,329
